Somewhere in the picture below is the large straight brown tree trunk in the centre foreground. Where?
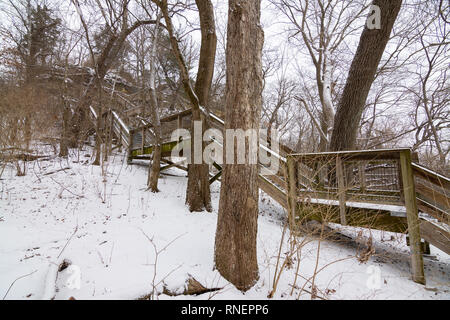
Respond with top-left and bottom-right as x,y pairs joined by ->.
215,0 -> 264,291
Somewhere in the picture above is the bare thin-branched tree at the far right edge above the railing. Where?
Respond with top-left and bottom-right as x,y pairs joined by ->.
406,4 -> 450,172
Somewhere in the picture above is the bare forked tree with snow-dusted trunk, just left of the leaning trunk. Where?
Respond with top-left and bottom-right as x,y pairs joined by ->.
272,0 -> 367,151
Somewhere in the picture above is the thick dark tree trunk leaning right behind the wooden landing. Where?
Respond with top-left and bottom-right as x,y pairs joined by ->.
330,0 -> 402,151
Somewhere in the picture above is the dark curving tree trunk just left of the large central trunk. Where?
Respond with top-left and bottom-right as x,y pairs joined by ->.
186,0 -> 217,212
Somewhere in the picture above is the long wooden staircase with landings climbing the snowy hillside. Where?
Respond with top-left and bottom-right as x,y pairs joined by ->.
91,108 -> 450,283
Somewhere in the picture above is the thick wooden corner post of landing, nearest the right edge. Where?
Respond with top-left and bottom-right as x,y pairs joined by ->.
400,150 -> 425,284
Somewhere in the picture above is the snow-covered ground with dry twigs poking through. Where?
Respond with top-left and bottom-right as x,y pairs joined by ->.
0,146 -> 450,299
